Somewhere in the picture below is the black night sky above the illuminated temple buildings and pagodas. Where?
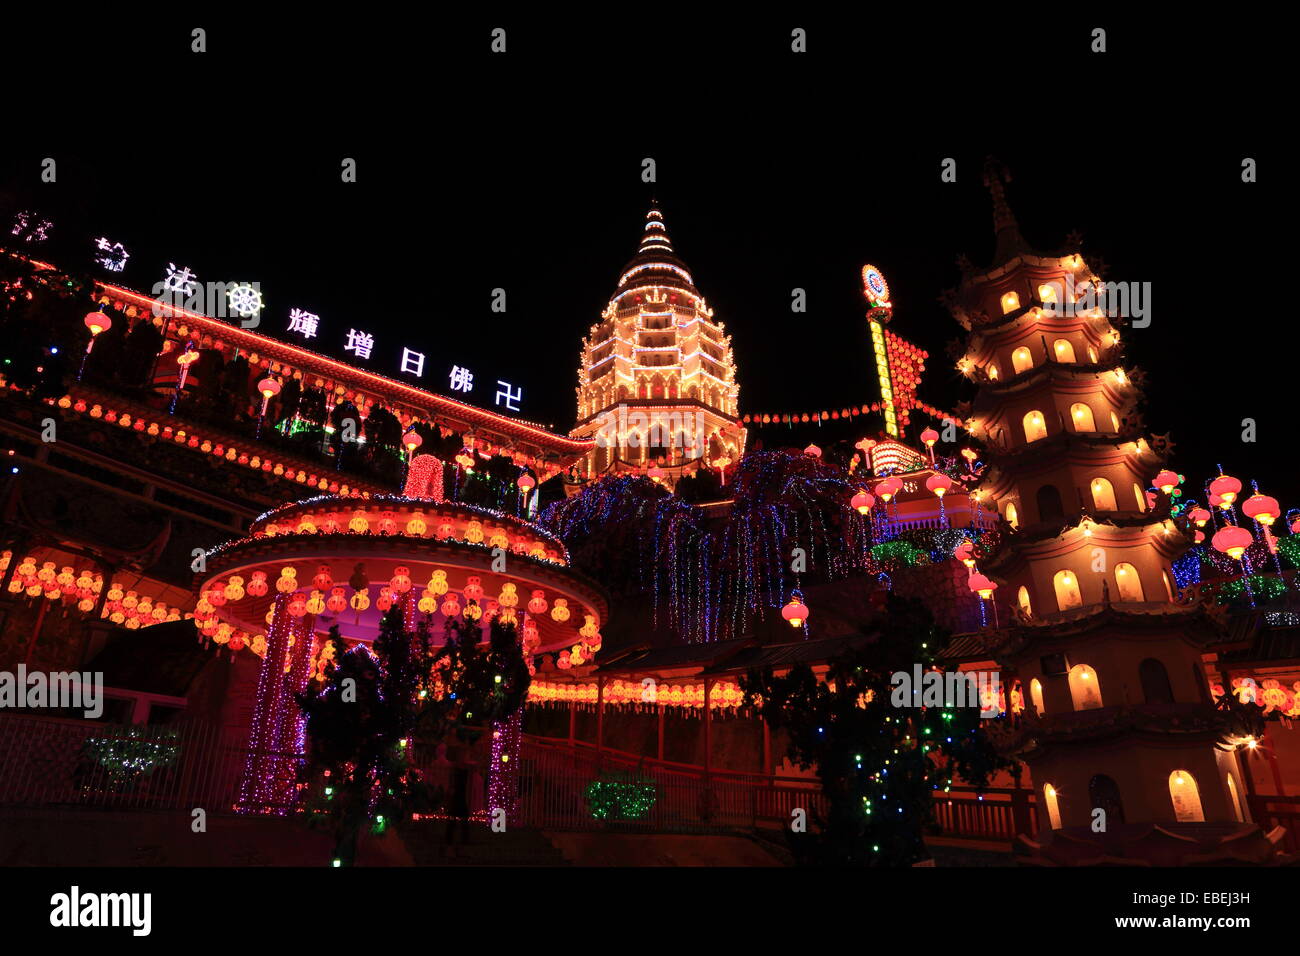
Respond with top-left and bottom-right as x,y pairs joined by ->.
0,20 -> 1279,507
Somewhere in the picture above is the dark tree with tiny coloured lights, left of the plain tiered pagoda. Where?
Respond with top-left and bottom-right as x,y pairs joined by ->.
741,597 -> 1011,866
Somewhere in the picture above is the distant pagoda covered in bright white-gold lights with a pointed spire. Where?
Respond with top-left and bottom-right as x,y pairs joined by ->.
571,204 -> 745,486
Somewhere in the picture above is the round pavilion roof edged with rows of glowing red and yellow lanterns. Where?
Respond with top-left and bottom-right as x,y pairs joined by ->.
195,496 -> 608,653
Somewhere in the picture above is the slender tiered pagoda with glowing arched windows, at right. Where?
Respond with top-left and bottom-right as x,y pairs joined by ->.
945,161 -> 1268,862
